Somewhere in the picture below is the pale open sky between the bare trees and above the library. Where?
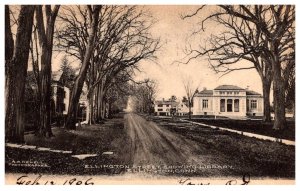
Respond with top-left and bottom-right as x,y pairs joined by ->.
136,6 -> 262,99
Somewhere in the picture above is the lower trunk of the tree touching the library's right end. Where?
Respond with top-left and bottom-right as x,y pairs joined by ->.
262,79 -> 272,122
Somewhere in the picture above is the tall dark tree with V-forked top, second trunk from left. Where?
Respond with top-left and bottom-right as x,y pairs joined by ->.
36,5 -> 60,137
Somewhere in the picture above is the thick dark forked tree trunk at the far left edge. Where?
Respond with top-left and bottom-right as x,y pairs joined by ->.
5,5 -> 35,143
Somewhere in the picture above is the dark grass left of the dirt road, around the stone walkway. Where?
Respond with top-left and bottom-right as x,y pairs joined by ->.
5,112 -> 128,175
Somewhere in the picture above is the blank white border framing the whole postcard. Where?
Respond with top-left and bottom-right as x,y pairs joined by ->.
0,0 -> 300,191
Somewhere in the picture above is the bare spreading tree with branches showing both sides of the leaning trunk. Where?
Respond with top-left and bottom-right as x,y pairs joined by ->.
58,6 -> 159,123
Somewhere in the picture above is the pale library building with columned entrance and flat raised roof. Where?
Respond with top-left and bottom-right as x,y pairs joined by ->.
193,85 -> 264,116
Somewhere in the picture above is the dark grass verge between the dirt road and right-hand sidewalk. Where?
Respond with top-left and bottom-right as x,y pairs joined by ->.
152,118 -> 295,178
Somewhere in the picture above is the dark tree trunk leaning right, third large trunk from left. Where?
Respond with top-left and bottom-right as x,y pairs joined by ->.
65,5 -> 102,129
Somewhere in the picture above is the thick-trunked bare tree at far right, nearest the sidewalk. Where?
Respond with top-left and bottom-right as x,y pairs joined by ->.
259,5 -> 295,129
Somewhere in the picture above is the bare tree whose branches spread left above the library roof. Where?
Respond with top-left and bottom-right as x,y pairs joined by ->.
184,5 -> 272,122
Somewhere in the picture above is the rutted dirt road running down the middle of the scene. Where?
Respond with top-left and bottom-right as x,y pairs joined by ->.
124,113 -> 232,176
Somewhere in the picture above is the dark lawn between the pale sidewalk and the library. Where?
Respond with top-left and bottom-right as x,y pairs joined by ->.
191,118 -> 295,141
